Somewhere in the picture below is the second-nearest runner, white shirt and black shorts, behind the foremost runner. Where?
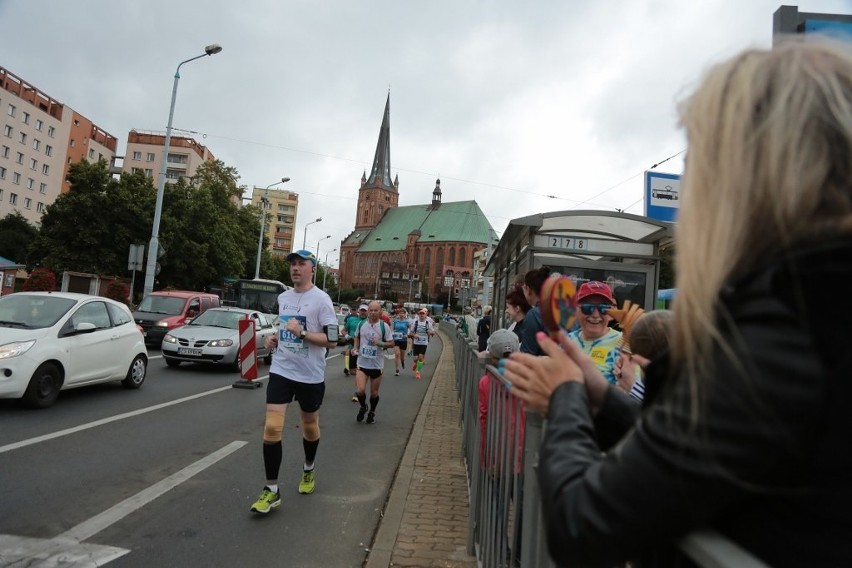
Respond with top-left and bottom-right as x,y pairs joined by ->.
355,302 -> 393,424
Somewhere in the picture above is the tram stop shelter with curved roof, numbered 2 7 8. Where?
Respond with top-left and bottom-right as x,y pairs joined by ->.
484,210 -> 674,325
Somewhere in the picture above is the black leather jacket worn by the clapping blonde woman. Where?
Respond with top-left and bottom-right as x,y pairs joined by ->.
539,240 -> 852,567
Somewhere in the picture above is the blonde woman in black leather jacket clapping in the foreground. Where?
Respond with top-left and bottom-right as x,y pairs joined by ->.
504,37 -> 852,567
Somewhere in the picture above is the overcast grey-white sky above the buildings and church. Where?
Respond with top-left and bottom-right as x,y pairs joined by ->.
0,0 -> 852,264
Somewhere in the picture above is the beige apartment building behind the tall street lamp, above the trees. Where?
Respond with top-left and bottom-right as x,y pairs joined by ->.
122,129 -> 216,186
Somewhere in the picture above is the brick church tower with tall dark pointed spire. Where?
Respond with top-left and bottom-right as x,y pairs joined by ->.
355,93 -> 399,230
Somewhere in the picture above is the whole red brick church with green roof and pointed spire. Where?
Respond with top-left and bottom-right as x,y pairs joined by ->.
340,95 -> 494,305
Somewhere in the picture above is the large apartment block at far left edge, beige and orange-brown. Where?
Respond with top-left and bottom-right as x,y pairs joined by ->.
0,67 -> 118,224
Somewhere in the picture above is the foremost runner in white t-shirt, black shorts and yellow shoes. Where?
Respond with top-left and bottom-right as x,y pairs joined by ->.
251,250 -> 337,514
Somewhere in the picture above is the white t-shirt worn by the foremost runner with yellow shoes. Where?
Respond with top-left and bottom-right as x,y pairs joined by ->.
269,286 -> 337,383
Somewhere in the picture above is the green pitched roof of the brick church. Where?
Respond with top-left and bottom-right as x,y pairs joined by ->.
346,201 -> 492,252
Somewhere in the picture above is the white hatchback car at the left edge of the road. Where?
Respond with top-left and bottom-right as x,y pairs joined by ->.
0,292 -> 148,408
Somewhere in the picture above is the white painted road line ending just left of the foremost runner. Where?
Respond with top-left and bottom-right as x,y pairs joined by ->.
56,442 -> 248,542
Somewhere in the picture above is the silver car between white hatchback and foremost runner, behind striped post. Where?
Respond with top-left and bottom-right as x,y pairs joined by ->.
162,307 -> 276,370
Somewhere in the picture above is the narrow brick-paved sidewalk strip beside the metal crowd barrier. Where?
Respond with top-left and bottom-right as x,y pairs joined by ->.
365,330 -> 477,568
